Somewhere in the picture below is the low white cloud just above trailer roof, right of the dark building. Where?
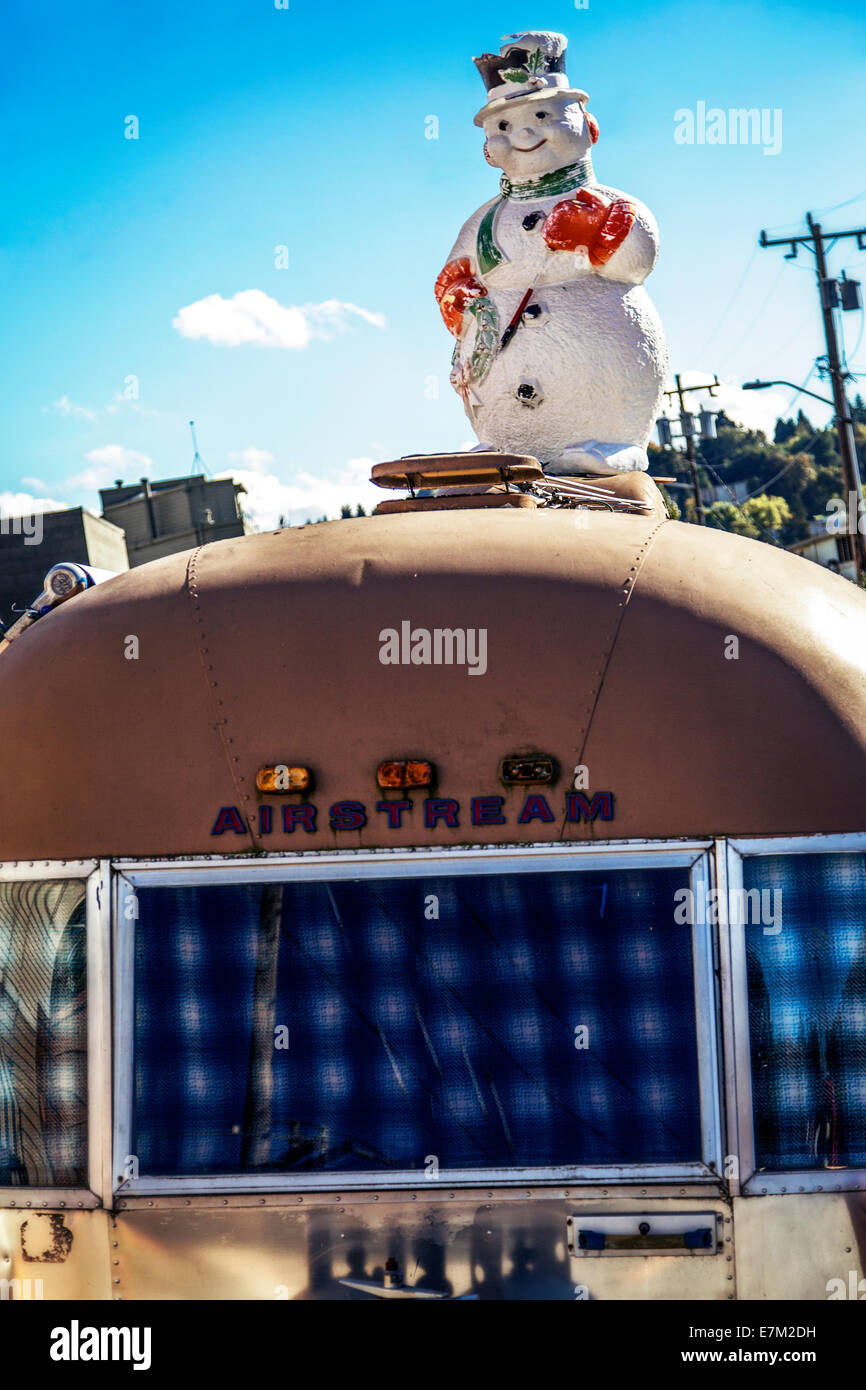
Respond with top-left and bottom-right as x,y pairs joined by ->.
217,450 -> 388,531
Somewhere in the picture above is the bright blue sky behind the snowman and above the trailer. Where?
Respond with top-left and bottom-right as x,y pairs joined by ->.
0,0 -> 866,524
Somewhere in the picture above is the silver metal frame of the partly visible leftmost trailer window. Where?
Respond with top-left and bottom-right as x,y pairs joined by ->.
0,859 -> 111,1209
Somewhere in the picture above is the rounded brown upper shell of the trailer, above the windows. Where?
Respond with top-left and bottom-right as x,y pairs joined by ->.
0,507 -> 866,860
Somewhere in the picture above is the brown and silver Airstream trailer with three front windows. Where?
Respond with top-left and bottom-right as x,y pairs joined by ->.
0,456 -> 866,1300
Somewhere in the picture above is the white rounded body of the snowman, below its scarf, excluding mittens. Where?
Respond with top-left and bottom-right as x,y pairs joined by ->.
449,183 -> 667,473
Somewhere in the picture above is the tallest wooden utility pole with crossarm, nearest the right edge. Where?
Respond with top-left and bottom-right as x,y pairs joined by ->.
759,213 -> 866,581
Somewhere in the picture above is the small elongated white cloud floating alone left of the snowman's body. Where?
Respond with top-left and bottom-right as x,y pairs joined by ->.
172,289 -> 385,349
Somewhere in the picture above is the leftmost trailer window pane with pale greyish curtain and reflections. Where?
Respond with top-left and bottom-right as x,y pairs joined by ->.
0,880 -> 88,1187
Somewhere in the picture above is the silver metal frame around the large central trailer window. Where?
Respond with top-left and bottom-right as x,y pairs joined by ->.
113,840 -> 723,1197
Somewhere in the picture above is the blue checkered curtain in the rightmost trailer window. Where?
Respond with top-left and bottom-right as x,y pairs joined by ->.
742,853 -> 866,1172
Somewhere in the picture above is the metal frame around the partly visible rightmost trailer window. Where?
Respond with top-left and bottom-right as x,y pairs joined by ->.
716,833 -> 866,1197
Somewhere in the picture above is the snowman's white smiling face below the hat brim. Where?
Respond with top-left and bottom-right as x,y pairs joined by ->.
484,96 -> 592,182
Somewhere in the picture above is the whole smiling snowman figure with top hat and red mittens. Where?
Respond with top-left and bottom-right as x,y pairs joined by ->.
436,32 -> 667,475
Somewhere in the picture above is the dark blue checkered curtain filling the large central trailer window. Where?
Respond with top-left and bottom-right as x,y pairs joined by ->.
132,869 -> 701,1176
